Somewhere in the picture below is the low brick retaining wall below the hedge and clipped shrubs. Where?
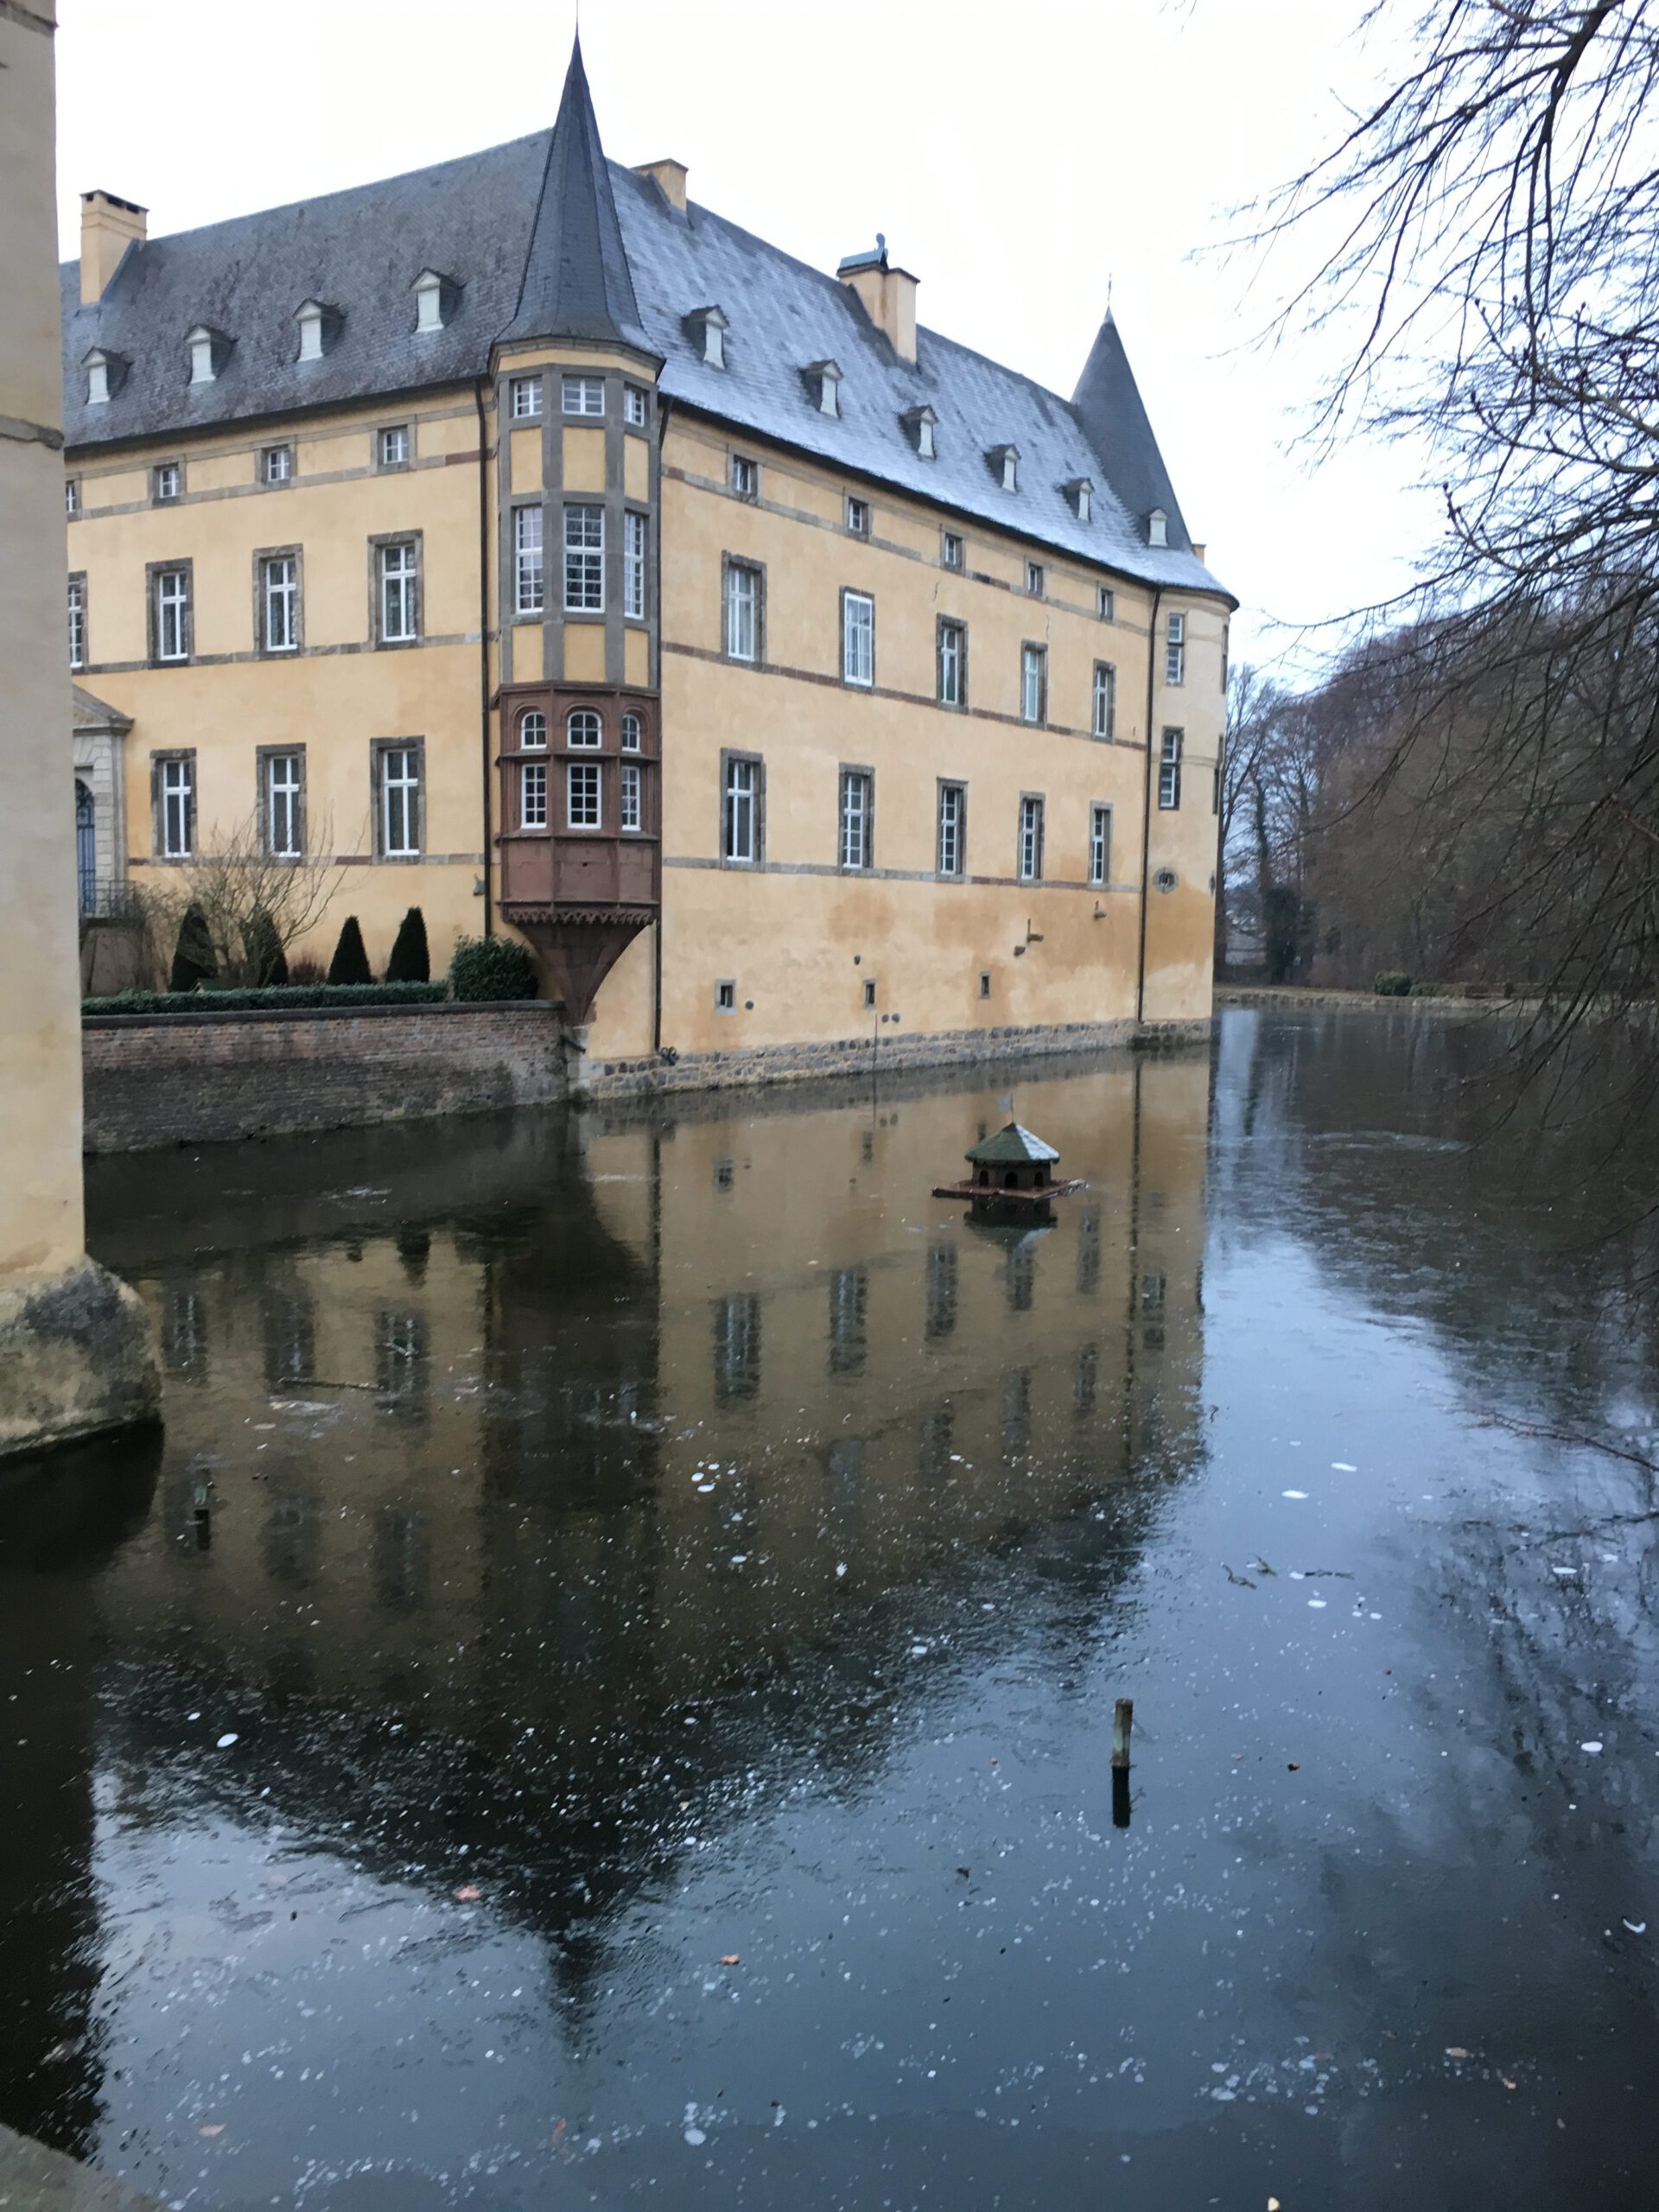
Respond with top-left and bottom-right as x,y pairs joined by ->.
82,1002 -> 566,1153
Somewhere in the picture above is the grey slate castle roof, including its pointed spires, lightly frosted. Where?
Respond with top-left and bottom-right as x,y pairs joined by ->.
62,48 -> 1225,593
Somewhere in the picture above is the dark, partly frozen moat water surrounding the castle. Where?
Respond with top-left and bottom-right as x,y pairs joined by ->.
0,1013 -> 1659,2212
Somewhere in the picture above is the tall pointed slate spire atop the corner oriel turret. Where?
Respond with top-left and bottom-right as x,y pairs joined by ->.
502,38 -> 639,345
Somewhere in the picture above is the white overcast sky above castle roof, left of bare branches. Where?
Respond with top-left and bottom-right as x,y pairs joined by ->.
58,0 -> 1438,672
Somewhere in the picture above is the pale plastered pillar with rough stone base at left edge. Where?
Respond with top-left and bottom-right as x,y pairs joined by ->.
0,0 -> 159,1453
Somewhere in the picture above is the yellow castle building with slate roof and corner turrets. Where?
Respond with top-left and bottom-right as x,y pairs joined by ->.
64,48 -> 1236,1075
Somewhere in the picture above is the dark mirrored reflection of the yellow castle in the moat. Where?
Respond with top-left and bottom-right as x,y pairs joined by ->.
68,1059 -> 1208,1973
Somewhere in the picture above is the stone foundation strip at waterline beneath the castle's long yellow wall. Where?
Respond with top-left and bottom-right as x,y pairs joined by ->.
570,1022 -> 1210,1102
